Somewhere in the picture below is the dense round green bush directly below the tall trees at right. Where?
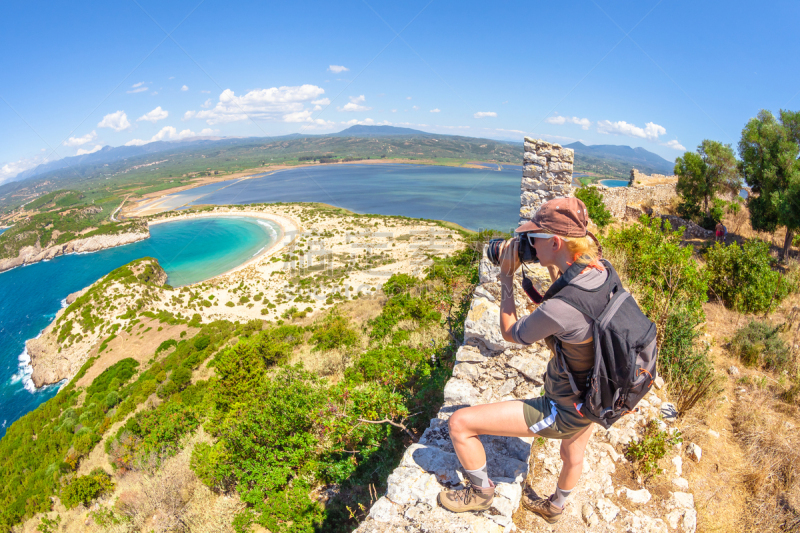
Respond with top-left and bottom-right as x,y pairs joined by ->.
706,239 -> 797,313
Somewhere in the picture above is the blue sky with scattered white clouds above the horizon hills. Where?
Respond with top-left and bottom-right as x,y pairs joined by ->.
0,0 -> 800,182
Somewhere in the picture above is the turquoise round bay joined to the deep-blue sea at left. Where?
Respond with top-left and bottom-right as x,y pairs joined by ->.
0,217 -> 279,437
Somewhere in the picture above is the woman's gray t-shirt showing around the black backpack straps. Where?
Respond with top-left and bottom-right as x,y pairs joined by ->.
511,268 -> 608,344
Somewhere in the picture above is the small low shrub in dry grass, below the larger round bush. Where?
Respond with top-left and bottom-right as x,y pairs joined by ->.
730,320 -> 791,370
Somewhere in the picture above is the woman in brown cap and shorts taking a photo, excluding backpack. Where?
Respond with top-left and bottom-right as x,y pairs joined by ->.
439,198 -> 608,523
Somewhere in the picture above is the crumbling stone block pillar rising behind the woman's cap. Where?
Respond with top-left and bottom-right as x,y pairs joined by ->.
519,137 -> 575,224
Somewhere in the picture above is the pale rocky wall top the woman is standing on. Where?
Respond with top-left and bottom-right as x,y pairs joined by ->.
356,259 -> 697,533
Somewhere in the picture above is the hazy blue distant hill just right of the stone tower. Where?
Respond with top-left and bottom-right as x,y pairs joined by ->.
565,142 -> 675,176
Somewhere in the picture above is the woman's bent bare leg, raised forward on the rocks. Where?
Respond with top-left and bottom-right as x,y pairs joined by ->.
449,401 -> 536,470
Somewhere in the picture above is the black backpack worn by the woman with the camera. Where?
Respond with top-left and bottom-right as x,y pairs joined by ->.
523,259 -> 658,429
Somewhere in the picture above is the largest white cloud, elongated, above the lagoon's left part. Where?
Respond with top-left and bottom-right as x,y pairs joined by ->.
192,85 -> 325,126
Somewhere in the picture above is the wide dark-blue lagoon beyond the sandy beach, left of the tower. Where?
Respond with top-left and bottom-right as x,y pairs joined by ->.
177,164 -> 522,231
